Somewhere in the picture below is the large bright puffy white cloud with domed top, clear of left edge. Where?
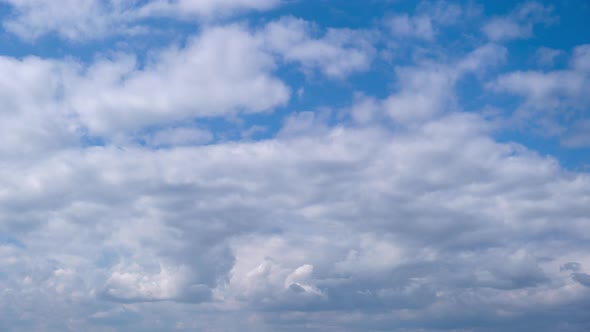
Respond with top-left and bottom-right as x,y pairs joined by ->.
67,26 -> 289,133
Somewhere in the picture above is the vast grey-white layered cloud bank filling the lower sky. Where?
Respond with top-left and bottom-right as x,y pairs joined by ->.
0,114 -> 590,331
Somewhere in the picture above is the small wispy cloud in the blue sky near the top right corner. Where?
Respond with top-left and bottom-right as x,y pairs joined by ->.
482,2 -> 555,41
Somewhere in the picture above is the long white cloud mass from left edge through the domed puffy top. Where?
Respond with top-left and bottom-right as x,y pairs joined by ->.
0,26 -> 290,141
